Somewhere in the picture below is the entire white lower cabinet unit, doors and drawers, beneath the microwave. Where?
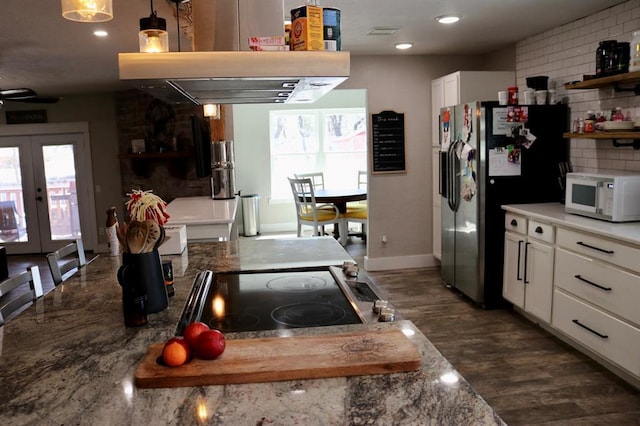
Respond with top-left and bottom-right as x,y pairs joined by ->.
502,205 -> 640,385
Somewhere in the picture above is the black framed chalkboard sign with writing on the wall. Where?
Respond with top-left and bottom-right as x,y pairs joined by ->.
371,111 -> 405,173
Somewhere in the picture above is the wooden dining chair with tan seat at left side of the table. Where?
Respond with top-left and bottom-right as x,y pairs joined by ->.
287,178 -> 342,237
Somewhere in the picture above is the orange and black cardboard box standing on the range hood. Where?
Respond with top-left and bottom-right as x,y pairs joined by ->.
290,5 -> 324,50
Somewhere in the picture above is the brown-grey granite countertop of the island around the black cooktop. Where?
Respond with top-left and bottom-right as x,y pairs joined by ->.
0,240 -> 504,425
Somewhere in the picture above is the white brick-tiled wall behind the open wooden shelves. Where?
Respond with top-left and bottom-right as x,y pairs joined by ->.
516,0 -> 640,171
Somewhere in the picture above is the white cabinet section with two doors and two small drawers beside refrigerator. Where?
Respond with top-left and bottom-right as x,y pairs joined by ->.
502,214 -> 554,323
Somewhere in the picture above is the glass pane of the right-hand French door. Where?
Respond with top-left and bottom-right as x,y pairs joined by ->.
42,144 -> 81,240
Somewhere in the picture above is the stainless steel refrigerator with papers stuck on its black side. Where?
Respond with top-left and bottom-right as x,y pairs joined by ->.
439,102 -> 569,309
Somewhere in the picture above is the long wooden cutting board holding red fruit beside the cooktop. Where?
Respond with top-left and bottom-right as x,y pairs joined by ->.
135,330 -> 421,388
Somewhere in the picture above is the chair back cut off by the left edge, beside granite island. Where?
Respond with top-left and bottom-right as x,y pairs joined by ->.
0,265 -> 44,326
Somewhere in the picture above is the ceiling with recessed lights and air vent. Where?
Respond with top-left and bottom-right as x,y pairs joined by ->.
0,0 -> 622,96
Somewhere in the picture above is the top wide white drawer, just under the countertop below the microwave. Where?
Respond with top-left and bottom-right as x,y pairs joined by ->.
556,228 -> 640,272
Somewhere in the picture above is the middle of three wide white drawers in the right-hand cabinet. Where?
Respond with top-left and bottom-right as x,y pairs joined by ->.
554,248 -> 640,325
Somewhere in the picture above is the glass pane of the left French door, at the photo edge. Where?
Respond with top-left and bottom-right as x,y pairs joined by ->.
0,146 -> 27,243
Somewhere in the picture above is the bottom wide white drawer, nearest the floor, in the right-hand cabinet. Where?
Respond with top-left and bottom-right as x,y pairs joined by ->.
552,290 -> 640,377
